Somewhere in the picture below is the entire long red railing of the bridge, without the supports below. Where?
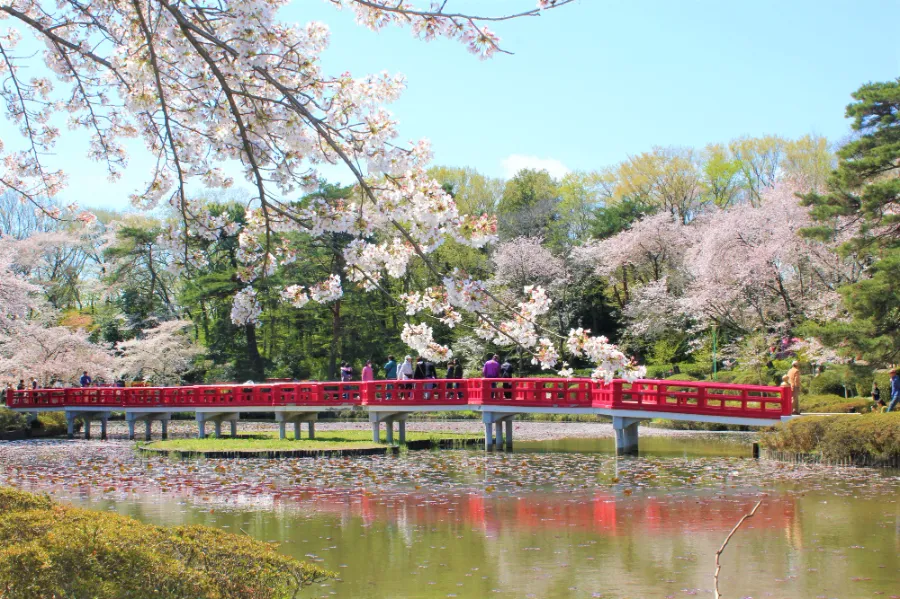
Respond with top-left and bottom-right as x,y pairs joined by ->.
6,378 -> 791,419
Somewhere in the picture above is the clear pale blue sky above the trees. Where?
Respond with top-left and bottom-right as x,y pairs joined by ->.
0,0 -> 900,208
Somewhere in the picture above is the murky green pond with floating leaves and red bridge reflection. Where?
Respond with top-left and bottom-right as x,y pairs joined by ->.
0,435 -> 900,599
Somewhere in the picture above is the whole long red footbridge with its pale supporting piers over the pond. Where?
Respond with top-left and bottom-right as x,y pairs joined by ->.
6,378 -> 791,452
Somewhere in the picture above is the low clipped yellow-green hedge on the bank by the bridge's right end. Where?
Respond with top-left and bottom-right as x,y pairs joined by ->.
760,413 -> 900,460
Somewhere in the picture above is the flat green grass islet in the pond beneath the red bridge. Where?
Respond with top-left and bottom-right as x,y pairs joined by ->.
147,430 -> 474,452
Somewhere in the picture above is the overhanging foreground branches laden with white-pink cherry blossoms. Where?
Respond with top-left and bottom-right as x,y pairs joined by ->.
0,0 -> 640,378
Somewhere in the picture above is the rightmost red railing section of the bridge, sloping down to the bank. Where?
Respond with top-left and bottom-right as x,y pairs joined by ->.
593,379 -> 791,418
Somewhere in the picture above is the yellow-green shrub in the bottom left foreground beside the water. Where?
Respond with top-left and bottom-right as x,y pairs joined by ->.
0,488 -> 335,599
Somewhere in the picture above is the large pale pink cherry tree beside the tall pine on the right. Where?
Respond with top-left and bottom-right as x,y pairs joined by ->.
683,182 -> 861,331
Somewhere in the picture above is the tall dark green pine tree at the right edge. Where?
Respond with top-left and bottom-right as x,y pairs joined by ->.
804,79 -> 900,364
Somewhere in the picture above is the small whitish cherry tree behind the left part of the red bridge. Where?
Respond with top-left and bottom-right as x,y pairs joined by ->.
116,320 -> 201,385
